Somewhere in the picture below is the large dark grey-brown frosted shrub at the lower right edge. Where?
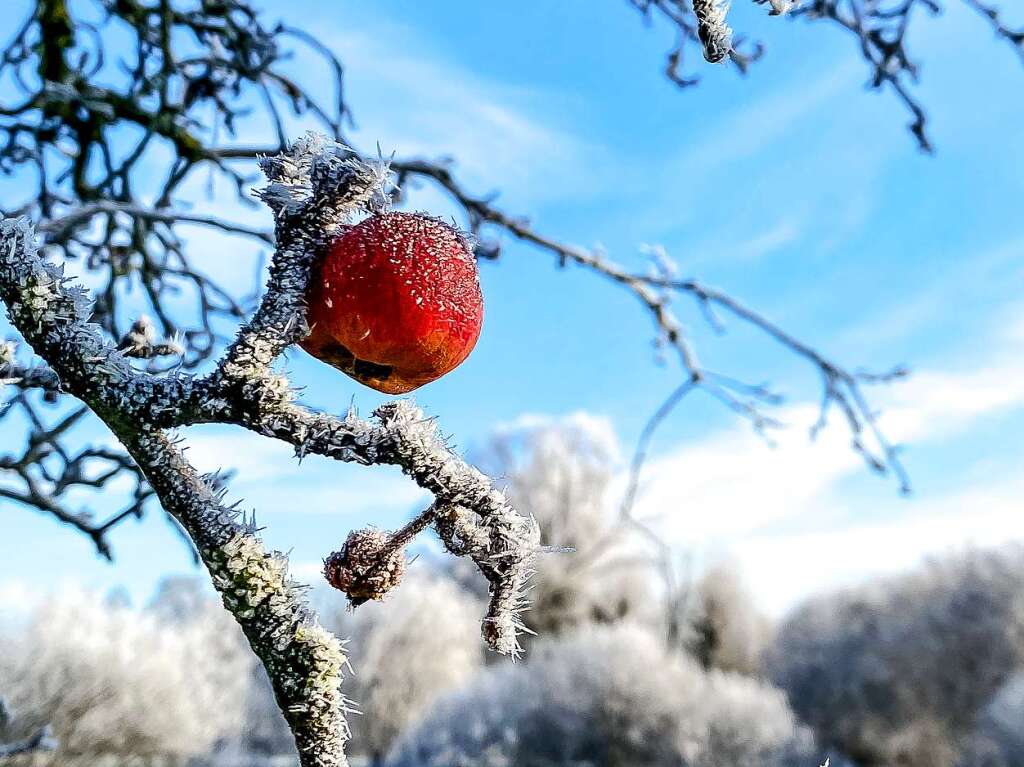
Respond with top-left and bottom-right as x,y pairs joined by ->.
768,546 -> 1024,767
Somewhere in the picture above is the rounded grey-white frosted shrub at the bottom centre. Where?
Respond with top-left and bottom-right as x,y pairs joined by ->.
387,625 -> 820,767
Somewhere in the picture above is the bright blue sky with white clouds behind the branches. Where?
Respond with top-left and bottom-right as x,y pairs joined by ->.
0,0 -> 1024,612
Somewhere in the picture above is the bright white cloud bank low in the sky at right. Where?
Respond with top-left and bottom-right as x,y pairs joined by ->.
407,311 -> 1024,614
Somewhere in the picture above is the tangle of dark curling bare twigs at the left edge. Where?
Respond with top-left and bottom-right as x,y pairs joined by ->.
0,0 -> 329,544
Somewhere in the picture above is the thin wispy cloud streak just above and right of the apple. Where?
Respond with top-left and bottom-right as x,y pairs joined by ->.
324,26 -> 609,204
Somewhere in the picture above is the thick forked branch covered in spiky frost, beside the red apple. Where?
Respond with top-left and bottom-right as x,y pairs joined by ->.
0,135 -> 539,767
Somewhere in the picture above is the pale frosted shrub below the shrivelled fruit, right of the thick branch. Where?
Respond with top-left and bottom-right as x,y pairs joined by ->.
336,578 -> 483,759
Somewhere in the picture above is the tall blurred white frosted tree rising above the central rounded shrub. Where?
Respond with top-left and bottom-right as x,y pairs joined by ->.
477,414 -> 772,675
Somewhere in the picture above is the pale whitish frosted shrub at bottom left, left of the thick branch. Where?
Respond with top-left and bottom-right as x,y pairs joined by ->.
0,581 -> 252,765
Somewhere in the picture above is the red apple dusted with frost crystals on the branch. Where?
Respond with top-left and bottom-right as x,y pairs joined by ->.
300,213 -> 483,394
